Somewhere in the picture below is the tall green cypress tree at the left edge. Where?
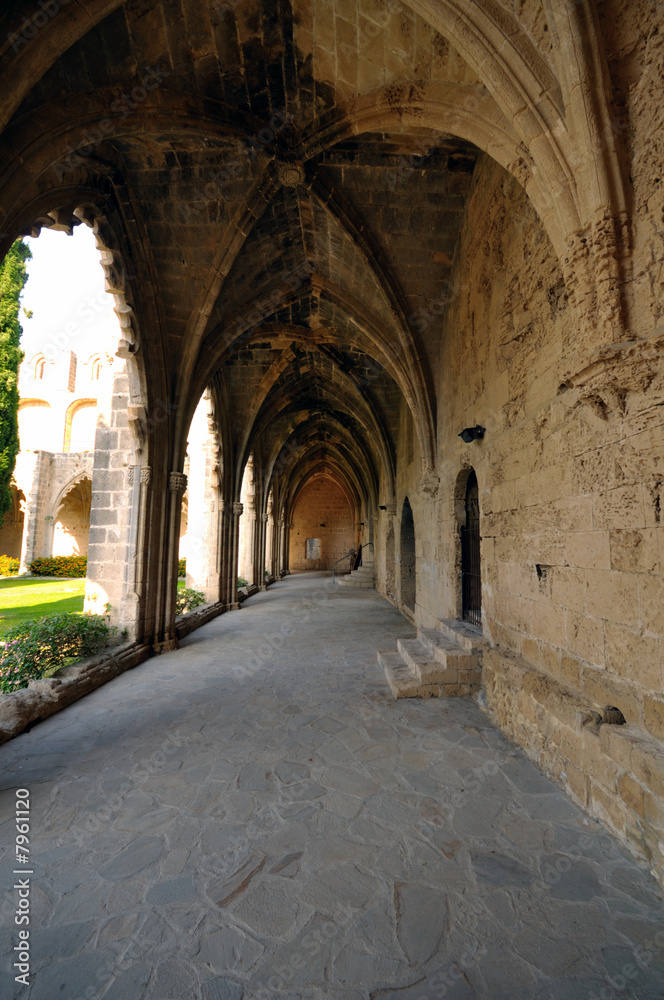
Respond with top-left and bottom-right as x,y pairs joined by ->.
0,240 -> 32,524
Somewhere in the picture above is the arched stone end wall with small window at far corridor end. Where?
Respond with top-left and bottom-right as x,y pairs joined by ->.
290,478 -> 355,570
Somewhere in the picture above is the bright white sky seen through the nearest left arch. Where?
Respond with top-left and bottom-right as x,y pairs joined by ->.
20,225 -> 118,361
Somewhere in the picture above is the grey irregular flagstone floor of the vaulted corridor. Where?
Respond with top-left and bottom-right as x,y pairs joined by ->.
0,575 -> 664,1000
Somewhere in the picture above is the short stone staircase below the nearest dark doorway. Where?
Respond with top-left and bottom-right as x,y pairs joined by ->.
378,621 -> 488,698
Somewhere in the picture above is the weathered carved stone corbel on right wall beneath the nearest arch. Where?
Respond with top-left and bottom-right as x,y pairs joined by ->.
564,327 -> 664,420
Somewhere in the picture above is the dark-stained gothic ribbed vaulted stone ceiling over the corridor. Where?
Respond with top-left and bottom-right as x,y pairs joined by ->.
0,0 -> 612,512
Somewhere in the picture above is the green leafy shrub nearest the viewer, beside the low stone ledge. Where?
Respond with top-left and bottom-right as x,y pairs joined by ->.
0,612 -> 117,694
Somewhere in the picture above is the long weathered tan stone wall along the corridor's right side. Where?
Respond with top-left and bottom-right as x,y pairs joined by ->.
381,154 -> 664,874
